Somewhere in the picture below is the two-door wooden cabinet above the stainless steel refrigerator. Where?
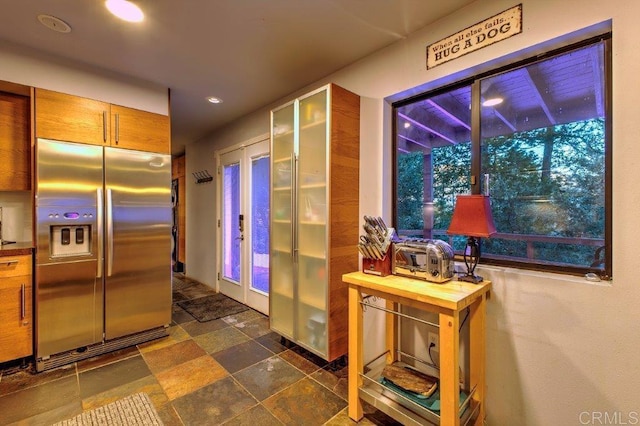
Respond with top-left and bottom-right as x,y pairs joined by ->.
35,89 -> 171,154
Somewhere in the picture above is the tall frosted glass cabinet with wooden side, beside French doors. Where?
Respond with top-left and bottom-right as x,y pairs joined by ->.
269,84 -> 360,361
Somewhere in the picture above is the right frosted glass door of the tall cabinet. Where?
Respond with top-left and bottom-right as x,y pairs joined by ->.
296,89 -> 329,354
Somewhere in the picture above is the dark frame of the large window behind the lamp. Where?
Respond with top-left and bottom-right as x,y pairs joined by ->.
391,32 -> 613,280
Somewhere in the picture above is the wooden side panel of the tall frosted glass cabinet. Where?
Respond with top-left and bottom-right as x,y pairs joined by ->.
328,85 -> 360,359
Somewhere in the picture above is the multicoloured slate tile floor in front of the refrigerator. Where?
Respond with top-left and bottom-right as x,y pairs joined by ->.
0,275 -> 397,426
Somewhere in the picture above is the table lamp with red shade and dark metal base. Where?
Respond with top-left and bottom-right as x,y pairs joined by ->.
447,195 -> 496,284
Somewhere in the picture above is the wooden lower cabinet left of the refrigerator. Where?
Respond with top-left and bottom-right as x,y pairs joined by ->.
0,255 -> 33,362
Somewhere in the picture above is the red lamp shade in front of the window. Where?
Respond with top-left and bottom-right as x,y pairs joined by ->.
447,195 -> 496,237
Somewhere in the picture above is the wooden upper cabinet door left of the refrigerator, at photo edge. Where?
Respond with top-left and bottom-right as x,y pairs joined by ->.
0,92 -> 31,191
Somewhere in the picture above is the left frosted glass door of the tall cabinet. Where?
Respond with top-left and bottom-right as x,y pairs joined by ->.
269,103 -> 295,339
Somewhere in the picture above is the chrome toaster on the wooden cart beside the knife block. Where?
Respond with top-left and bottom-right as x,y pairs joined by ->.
392,239 -> 454,283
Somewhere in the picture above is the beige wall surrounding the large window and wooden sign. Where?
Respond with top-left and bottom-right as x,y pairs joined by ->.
187,0 -> 640,426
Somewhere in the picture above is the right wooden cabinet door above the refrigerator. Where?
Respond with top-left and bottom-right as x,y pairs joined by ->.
111,105 -> 171,154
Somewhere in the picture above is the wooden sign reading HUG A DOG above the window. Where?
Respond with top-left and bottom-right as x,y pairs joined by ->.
427,4 -> 522,69
